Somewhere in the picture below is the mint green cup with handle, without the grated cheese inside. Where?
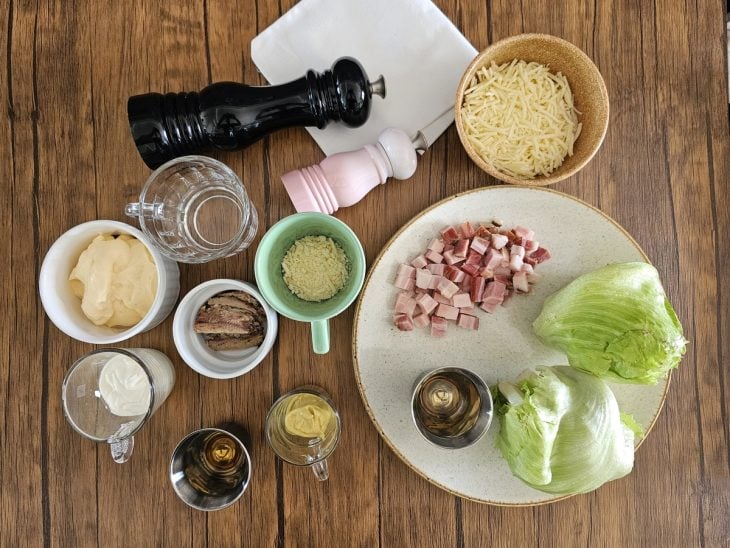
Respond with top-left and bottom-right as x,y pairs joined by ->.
254,213 -> 365,354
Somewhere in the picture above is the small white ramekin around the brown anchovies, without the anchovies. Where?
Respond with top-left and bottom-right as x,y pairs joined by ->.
172,279 -> 279,379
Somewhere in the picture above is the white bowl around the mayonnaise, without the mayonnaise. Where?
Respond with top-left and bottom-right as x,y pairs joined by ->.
38,221 -> 180,344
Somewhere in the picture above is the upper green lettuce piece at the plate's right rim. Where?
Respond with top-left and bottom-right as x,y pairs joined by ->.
532,263 -> 686,384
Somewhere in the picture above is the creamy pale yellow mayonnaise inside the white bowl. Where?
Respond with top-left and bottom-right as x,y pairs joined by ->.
69,234 -> 157,327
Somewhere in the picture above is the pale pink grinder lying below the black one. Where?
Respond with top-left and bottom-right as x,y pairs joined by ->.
281,128 -> 417,215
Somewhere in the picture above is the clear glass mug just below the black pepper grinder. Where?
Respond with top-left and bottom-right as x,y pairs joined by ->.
124,156 -> 258,263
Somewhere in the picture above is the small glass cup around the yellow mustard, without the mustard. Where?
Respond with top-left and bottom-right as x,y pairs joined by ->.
266,386 -> 342,481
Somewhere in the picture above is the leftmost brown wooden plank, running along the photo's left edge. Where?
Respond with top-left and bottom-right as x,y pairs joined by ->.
0,2 -> 50,545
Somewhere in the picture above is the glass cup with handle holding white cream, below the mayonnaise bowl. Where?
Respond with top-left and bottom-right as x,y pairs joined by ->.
61,348 -> 175,463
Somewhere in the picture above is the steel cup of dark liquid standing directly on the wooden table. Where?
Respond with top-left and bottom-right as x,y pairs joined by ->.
170,428 -> 251,511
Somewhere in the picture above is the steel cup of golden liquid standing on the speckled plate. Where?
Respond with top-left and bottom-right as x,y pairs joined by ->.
411,367 -> 492,449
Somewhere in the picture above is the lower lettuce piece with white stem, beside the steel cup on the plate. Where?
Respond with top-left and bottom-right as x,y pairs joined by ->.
495,366 -> 640,495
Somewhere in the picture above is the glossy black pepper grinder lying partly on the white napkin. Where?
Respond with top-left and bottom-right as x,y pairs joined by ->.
127,57 -> 385,169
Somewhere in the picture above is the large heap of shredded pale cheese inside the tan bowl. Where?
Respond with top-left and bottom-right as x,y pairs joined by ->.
461,59 -> 581,179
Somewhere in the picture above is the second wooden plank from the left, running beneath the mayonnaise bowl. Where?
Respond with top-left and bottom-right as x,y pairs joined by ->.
29,5 -> 105,545
